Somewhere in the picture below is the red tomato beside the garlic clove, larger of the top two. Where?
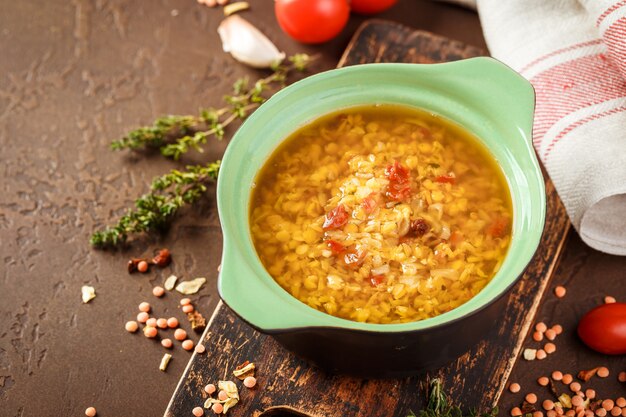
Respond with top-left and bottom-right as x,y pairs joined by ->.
274,0 -> 350,43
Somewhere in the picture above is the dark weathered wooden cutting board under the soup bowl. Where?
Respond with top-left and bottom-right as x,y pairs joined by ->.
165,20 -> 570,417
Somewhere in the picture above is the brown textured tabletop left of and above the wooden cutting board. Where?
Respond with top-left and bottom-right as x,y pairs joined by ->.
0,0 -> 484,417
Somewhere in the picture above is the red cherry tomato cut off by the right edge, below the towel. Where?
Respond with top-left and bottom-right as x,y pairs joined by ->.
578,303 -> 626,355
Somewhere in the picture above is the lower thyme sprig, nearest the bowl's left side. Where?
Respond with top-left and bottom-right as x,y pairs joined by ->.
90,161 -> 220,247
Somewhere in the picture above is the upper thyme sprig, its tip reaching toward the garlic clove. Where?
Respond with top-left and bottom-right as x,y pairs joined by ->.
111,54 -> 314,160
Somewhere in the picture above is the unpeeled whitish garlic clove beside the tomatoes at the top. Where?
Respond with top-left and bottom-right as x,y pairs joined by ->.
217,15 -> 285,68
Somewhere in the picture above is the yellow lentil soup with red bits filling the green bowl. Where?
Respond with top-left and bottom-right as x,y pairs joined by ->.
250,105 -> 512,323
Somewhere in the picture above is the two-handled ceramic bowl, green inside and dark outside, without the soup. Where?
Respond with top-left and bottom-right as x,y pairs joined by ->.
217,58 -> 545,375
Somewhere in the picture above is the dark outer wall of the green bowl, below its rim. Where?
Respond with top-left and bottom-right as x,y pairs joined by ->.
270,291 -> 509,378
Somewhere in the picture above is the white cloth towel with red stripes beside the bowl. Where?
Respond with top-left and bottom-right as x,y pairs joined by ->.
478,0 -> 626,255
